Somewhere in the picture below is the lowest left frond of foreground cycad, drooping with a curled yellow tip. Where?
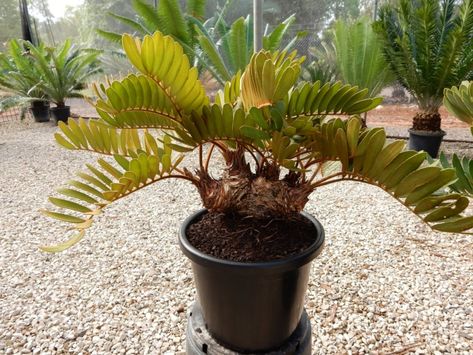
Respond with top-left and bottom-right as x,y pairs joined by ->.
41,137 -> 186,252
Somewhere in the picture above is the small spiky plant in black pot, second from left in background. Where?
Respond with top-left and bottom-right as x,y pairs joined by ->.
31,40 -> 101,121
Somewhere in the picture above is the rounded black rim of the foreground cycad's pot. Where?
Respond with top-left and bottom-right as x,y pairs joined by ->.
179,209 -> 325,273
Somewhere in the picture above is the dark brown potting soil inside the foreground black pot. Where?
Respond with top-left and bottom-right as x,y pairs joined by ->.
187,213 -> 317,262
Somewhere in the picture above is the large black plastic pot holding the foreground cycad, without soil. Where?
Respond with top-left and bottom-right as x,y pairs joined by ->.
179,210 -> 325,353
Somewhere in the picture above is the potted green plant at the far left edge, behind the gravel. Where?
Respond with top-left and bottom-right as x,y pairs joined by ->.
0,40 -> 49,122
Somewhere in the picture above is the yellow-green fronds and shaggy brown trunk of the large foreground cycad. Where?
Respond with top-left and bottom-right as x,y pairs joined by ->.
43,33 -> 473,252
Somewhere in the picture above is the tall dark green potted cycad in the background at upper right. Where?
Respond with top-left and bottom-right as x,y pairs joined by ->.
376,0 -> 473,158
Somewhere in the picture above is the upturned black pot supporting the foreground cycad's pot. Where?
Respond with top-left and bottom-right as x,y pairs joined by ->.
186,302 -> 312,355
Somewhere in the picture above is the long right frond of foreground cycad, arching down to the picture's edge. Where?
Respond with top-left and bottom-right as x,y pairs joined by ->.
311,118 -> 473,232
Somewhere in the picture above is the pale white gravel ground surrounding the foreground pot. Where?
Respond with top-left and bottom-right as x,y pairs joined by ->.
0,123 -> 473,354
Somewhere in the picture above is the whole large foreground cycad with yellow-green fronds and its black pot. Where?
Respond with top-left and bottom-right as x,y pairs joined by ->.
43,32 -> 473,353
